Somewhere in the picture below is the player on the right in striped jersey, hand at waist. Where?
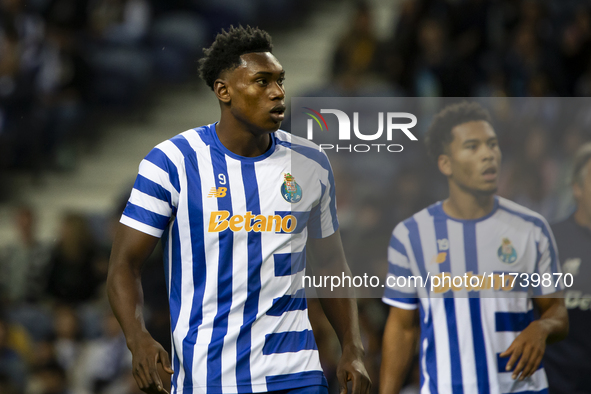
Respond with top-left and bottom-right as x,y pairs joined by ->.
380,102 -> 568,394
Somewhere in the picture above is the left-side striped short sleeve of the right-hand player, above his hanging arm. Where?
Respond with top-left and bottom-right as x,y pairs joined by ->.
382,223 -> 419,309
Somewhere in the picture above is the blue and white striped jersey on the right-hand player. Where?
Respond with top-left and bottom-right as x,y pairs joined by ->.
383,197 -> 562,394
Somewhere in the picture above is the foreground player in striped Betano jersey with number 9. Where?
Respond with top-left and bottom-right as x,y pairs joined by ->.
108,27 -> 370,394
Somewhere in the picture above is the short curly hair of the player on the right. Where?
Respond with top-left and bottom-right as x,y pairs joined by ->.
425,101 -> 492,161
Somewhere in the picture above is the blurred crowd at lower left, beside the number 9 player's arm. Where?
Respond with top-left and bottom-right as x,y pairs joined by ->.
0,200 -> 170,394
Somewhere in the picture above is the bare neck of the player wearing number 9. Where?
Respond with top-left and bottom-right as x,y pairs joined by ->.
216,117 -> 271,157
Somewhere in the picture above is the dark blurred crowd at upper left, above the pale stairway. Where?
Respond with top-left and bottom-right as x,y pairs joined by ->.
0,0 -> 310,199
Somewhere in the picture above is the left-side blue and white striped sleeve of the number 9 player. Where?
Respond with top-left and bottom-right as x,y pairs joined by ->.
120,147 -> 180,238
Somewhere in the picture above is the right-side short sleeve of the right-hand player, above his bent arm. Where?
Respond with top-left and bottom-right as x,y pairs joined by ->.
533,219 -> 564,296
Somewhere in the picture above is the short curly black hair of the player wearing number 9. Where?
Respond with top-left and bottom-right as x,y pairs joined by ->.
199,25 -> 273,90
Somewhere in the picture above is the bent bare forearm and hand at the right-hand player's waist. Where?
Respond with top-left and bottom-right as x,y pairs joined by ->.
500,297 -> 568,380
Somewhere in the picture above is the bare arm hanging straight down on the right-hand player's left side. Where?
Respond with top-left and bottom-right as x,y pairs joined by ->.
380,307 -> 420,394
